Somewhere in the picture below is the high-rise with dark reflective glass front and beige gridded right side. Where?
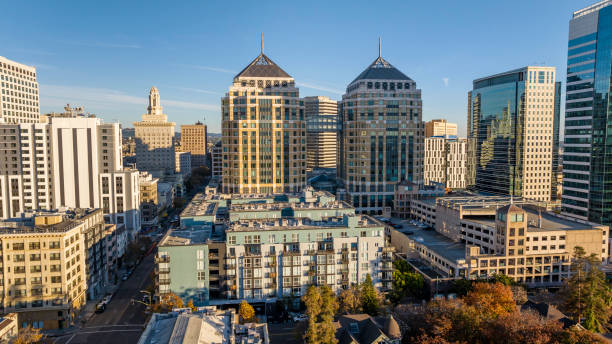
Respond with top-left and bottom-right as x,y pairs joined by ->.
468,66 -> 556,201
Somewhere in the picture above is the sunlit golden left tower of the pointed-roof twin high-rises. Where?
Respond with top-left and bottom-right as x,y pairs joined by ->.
221,48 -> 306,194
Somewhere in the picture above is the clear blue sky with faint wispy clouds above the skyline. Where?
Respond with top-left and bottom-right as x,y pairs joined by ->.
0,0 -> 594,135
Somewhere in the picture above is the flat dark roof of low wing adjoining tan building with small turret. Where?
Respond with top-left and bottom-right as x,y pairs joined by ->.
397,225 -> 465,262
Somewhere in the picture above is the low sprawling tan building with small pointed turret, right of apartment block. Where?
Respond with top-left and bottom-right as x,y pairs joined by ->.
391,196 -> 609,287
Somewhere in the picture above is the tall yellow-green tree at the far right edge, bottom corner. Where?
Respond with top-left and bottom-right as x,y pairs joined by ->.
565,246 -> 612,332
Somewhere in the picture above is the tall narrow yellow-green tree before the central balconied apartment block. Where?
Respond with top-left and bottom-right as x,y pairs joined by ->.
302,286 -> 338,344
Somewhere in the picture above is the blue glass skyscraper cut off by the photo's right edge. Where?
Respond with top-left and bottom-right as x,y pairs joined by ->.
562,1 -> 612,225
